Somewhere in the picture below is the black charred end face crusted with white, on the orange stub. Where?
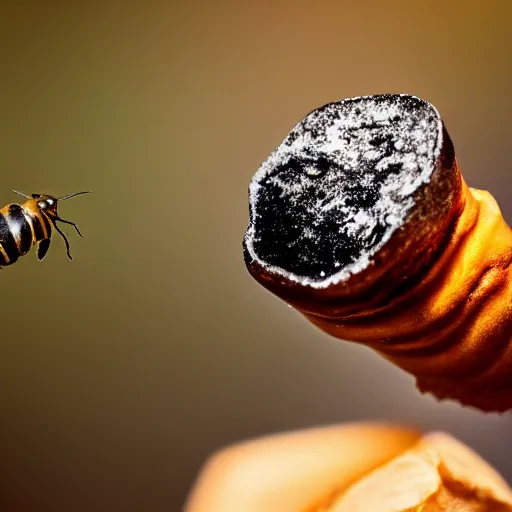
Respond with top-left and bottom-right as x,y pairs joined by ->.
244,94 -> 455,288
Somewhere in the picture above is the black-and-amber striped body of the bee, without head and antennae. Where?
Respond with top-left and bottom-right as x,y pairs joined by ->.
0,204 -> 52,267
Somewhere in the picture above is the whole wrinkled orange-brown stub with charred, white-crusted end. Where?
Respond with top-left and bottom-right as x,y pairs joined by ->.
244,94 -> 512,412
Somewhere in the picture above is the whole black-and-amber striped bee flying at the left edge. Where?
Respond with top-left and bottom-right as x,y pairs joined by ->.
0,190 -> 90,268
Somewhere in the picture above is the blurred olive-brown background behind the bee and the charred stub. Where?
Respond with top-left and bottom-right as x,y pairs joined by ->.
0,0 -> 512,512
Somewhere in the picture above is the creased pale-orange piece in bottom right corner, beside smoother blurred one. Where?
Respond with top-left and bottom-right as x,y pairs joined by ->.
308,433 -> 512,512
